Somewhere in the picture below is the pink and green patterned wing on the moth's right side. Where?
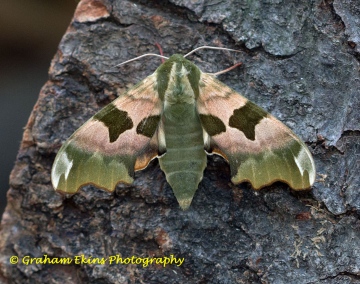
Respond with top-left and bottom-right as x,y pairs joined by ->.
197,73 -> 315,190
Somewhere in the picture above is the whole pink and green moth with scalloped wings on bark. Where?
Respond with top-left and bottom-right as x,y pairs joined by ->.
51,47 -> 315,210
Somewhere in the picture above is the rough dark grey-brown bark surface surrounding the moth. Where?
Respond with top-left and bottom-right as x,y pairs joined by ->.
0,0 -> 360,283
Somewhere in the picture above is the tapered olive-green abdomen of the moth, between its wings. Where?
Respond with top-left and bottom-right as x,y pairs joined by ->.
159,104 -> 207,210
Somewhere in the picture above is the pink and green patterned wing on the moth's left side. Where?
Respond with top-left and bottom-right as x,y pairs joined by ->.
51,74 -> 162,193
